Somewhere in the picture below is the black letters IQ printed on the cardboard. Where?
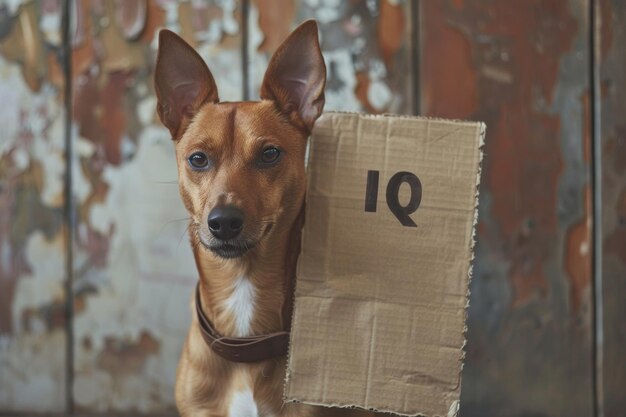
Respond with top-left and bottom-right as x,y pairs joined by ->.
365,171 -> 422,227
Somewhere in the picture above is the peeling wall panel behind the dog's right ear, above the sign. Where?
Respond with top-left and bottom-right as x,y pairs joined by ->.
248,0 -> 413,114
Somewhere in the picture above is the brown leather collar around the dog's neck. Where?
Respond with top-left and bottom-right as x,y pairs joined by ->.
196,283 -> 289,363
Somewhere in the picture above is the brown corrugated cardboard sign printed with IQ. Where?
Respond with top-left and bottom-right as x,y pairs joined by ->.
285,113 -> 485,416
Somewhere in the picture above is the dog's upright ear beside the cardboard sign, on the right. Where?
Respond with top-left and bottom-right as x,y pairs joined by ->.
261,20 -> 326,131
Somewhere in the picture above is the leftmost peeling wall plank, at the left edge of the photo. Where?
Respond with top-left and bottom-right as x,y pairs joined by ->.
0,1 -> 67,412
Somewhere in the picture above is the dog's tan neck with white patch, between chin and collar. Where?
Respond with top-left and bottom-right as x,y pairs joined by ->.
193,205 -> 304,337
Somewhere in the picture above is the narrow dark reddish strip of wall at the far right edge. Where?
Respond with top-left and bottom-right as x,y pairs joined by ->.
598,0 -> 626,417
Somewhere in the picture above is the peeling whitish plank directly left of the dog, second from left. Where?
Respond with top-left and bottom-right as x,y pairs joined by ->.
72,0 -> 242,414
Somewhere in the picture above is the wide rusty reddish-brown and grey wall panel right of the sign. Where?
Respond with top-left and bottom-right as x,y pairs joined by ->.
420,0 -> 593,417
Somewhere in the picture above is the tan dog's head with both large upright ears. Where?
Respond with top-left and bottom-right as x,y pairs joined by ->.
154,21 -> 326,258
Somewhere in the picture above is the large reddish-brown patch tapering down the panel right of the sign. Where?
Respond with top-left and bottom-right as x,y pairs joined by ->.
425,3 -> 577,305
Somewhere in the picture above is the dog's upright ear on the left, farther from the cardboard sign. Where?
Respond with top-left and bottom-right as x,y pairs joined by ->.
154,29 -> 219,139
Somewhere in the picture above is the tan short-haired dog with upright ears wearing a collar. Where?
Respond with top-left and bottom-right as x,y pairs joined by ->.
154,21 -> 372,417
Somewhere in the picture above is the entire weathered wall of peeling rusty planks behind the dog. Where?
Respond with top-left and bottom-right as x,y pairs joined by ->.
0,0 -> 626,417
